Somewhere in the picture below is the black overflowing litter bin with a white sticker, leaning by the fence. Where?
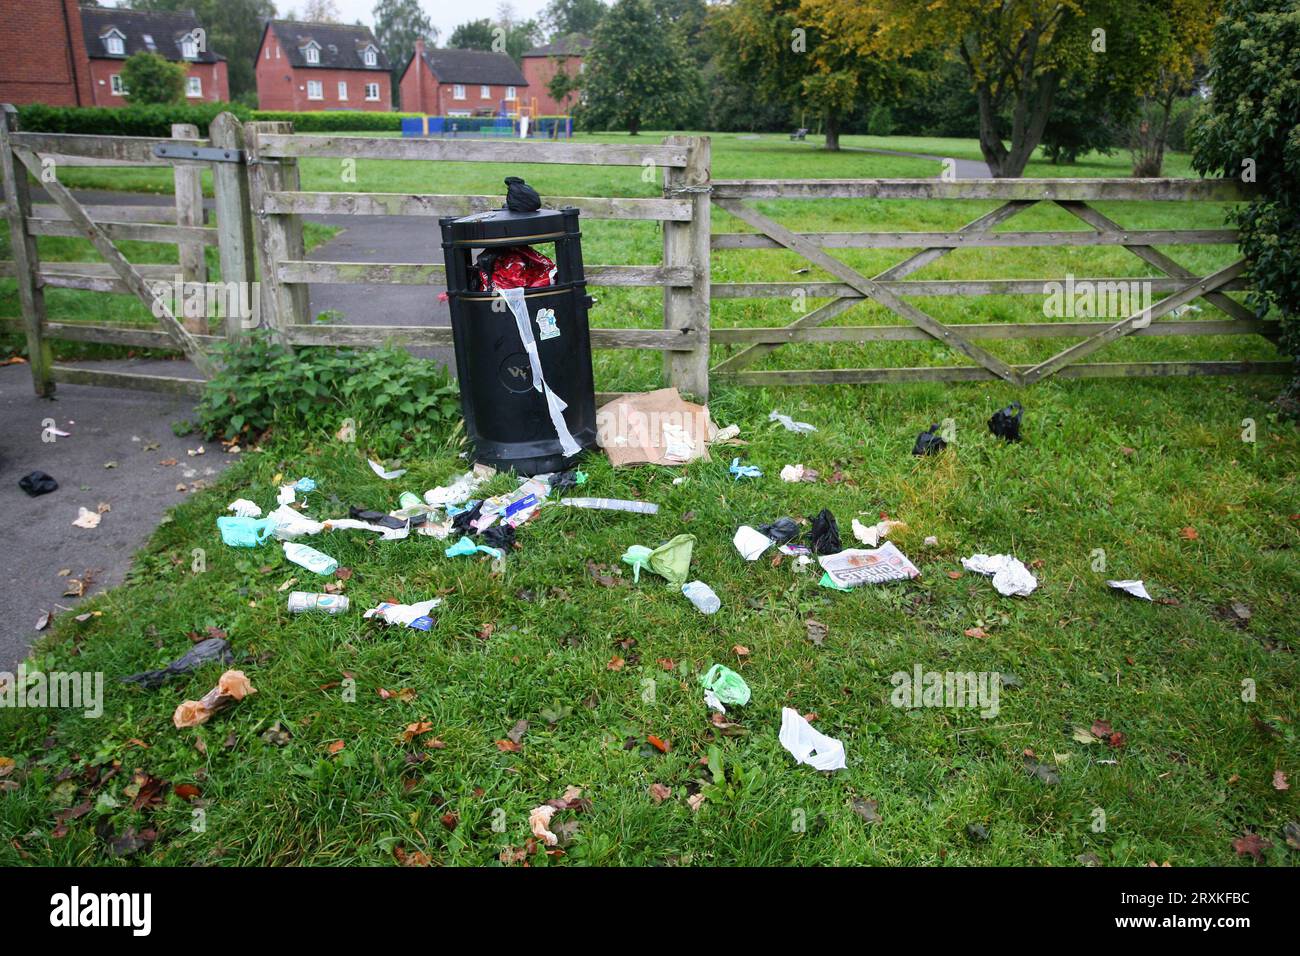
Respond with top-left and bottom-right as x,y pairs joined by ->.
439,195 -> 597,475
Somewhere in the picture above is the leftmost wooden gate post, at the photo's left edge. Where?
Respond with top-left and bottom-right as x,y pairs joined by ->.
0,103 -> 55,398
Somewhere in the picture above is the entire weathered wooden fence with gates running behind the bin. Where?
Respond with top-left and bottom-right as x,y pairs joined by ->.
0,107 -> 1290,398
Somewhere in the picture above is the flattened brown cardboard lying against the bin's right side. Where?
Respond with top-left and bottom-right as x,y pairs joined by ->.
595,388 -> 718,468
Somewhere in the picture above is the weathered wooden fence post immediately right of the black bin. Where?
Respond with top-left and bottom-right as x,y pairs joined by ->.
663,137 -> 711,402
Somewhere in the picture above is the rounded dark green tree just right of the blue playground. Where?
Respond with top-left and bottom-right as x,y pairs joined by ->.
576,0 -> 703,137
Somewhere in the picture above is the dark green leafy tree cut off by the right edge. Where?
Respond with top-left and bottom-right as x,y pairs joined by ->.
1192,0 -> 1300,415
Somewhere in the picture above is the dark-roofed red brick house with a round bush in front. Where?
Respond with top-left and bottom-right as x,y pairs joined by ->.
81,7 -> 230,107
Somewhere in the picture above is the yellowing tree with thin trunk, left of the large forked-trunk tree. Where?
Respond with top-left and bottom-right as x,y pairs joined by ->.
710,0 -> 909,150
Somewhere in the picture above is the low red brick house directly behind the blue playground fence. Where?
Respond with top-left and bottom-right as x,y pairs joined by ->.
398,40 -> 532,116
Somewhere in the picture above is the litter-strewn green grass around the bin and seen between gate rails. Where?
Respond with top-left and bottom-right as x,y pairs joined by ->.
0,128 -> 1300,866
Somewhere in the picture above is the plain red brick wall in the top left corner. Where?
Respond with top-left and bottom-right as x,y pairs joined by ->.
0,0 -> 91,107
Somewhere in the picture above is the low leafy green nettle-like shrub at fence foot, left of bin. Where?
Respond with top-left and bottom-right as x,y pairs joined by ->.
198,334 -> 460,455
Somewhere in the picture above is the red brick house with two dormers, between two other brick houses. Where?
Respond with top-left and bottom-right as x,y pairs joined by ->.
257,20 -> 393,112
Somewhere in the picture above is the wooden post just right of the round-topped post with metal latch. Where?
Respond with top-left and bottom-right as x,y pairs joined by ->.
244,122 -> 307,332
